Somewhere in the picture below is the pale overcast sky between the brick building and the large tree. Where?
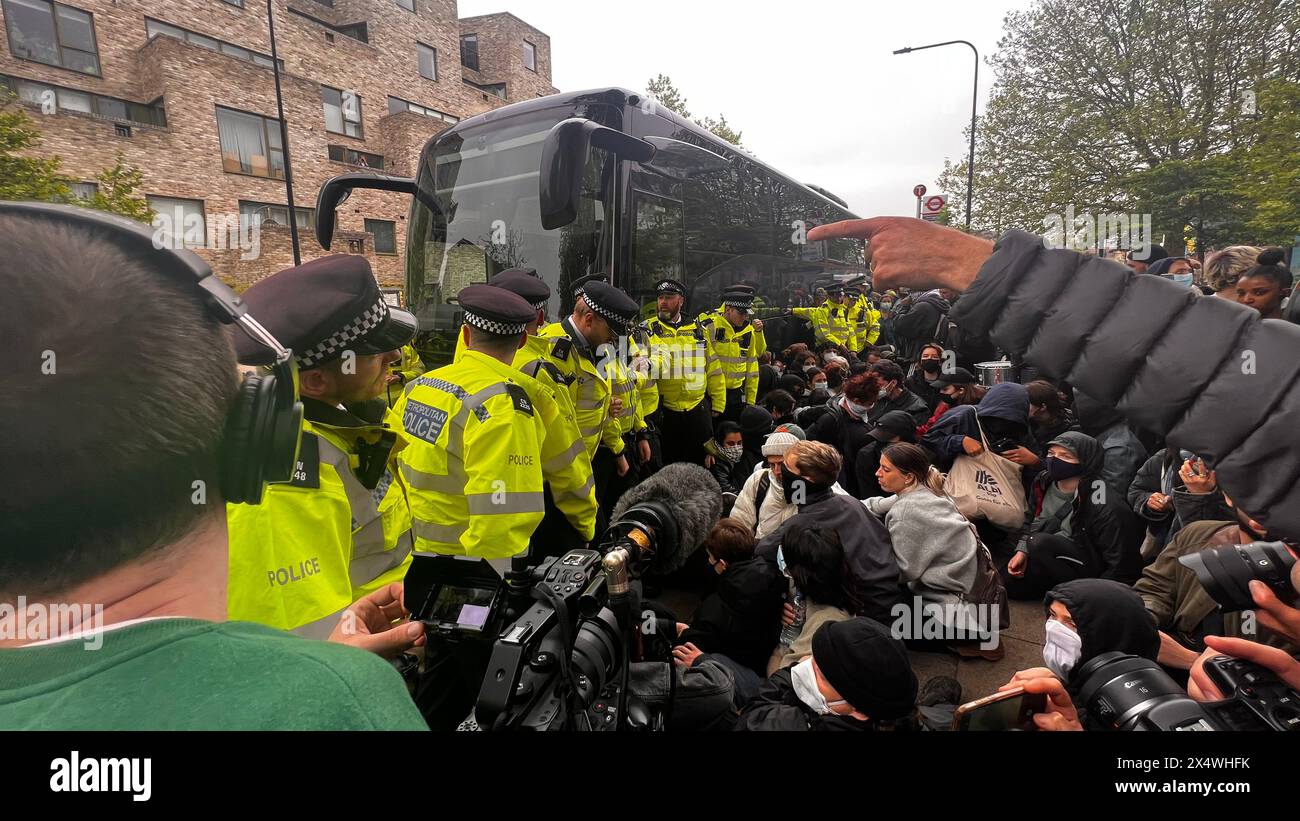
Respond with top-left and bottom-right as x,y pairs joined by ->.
459,0 -> 1032,216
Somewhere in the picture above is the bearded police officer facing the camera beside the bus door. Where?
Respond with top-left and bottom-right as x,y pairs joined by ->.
649,279 -> 727,465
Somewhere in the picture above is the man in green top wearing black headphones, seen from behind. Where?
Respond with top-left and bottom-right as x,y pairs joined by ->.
0,203 -> 425,730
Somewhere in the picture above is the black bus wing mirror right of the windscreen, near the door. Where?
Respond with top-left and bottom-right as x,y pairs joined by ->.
538,117 -> 655,231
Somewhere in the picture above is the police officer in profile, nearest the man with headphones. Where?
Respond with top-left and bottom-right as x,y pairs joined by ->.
226,255 -> 416,638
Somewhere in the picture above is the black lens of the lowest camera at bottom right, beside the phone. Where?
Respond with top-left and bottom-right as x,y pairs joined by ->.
1074,652 -> 1203,730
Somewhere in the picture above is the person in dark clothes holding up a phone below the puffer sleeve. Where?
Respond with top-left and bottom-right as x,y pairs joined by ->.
1128,448 -> 1232,561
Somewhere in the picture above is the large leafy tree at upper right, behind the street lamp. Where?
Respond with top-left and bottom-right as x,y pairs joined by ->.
940,0 -> 1300,242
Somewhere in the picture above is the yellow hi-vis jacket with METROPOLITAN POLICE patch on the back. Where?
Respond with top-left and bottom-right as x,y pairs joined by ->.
394,351 -> 547,559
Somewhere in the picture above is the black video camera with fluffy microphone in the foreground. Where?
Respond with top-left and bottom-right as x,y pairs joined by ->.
406,465 -> 722,730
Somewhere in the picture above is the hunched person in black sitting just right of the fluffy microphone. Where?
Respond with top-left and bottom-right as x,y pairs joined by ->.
673,518 -> 787,704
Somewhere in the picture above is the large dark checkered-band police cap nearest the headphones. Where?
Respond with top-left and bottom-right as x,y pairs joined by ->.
235,253 -> 416,370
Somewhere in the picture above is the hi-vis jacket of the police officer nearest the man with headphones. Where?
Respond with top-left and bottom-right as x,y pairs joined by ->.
226,399 -> 412,638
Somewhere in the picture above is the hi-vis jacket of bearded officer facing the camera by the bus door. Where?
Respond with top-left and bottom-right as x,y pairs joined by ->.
647,317 -> 727,413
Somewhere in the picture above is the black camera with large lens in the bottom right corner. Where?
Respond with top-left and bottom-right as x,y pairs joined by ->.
1076,652 -> 1300,733
